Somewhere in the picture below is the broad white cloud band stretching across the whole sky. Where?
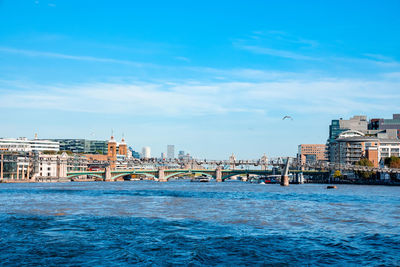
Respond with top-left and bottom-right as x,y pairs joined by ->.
0,74 -> 400,117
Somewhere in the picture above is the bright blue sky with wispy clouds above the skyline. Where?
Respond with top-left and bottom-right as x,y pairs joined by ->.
0,0 -> 400,159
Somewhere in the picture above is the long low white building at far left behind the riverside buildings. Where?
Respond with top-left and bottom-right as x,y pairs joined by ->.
0,137 -> 60,152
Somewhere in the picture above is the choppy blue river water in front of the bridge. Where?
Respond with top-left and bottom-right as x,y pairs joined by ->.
0,181 -> 400,266
